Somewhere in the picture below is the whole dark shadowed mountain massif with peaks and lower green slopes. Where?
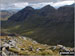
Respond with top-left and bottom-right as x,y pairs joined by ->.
2,5 -> 74,47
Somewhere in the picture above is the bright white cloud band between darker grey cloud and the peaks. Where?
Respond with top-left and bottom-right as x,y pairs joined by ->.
1,0 -> 74,10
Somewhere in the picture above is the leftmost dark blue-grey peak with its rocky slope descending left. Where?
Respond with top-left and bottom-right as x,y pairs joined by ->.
8,6 -> 34,21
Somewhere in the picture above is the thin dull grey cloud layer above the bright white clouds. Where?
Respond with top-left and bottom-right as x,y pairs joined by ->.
0,0 -> 72,4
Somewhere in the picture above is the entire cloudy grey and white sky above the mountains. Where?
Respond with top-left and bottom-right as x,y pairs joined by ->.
0,0 -> 74,9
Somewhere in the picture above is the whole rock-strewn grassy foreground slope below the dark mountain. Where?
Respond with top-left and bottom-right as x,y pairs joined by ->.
0,36 -> 73,56
